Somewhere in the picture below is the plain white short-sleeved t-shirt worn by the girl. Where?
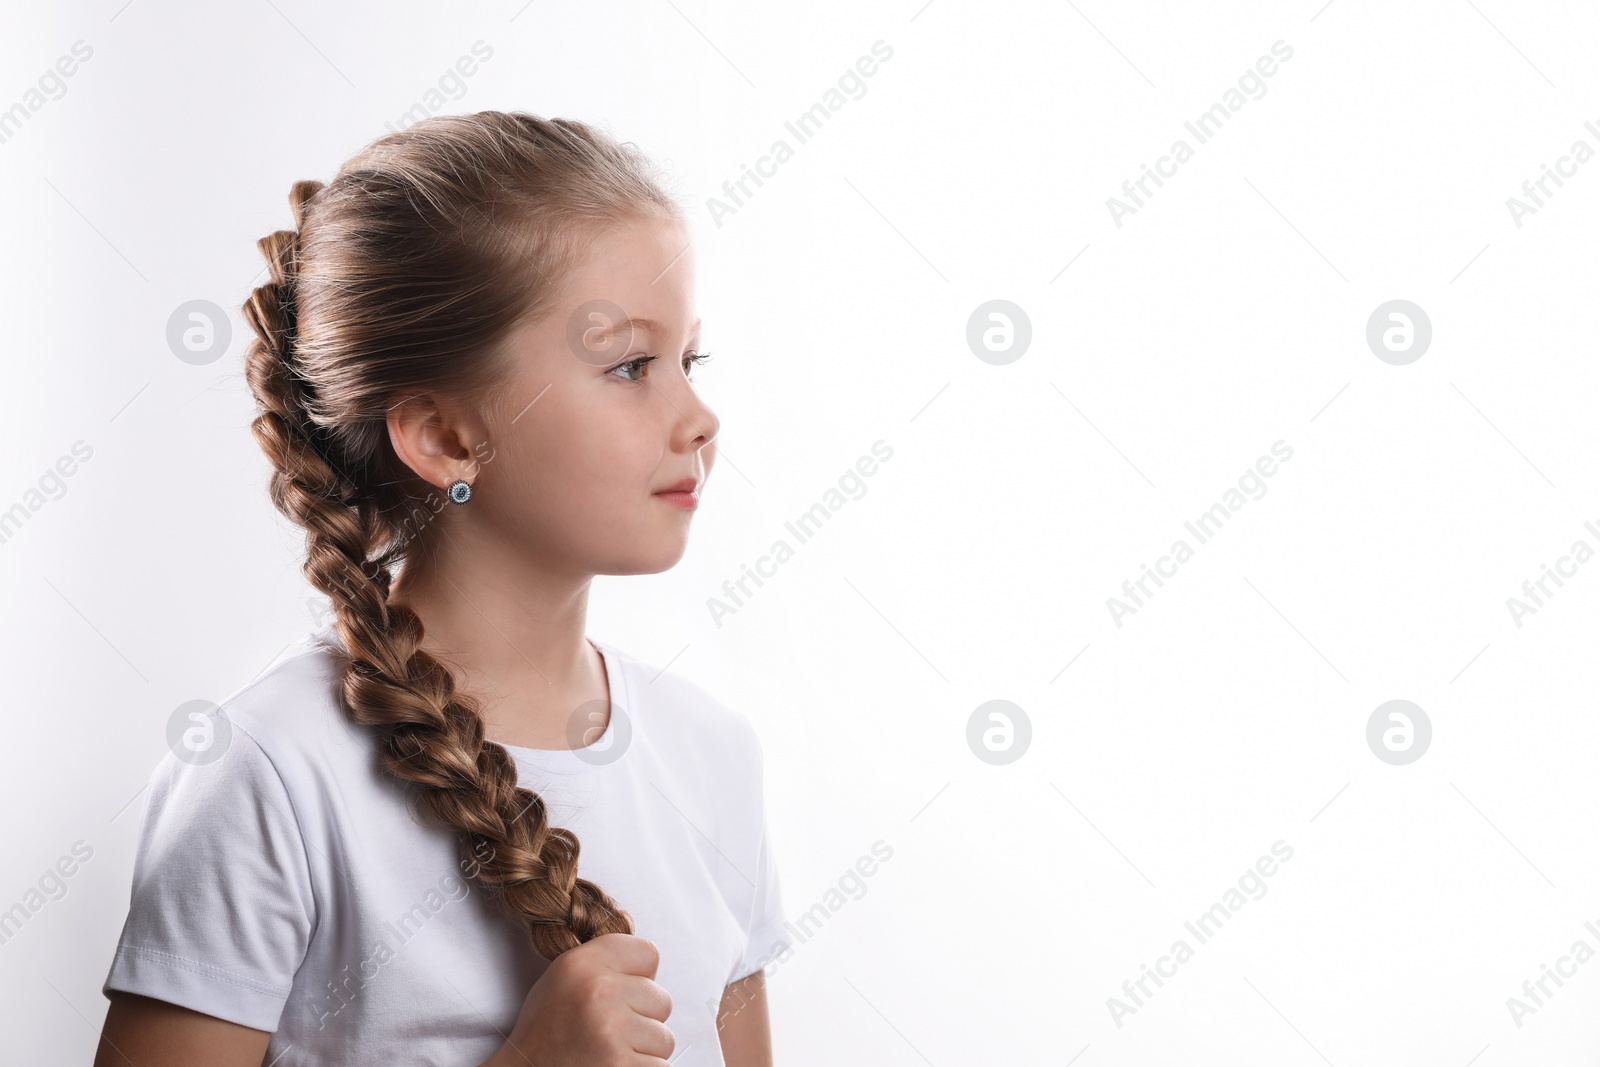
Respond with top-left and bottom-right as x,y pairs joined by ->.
102,625 -> 794,1067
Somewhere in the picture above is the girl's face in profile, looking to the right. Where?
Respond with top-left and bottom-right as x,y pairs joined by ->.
469,221 -> 720,574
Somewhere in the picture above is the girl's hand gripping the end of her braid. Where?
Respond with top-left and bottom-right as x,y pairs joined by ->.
483,934 -> 677,1067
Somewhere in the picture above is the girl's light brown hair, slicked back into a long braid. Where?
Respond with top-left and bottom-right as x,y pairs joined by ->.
243,112 -> 682,960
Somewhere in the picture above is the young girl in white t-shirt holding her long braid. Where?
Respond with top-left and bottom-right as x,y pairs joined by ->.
94,112 -> 792,1067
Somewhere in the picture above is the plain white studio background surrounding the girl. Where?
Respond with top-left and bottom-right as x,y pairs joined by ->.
0,0 -> 1600,1067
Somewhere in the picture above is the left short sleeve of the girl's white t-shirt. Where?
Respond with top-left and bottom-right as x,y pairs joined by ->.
101,723 -> 317,1032
